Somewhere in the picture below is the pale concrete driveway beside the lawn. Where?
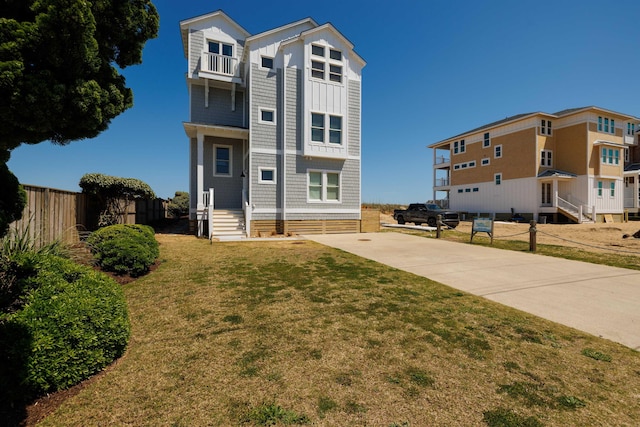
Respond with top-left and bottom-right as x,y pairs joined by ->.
304,233 -> 640,350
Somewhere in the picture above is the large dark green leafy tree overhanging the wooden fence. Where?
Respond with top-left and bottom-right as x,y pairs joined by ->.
0,0 -> 159,231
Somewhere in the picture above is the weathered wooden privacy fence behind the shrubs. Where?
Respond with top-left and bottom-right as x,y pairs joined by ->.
10,185 -> 166,245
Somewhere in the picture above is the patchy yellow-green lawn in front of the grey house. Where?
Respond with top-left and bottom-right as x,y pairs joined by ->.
42,235 -> 640,426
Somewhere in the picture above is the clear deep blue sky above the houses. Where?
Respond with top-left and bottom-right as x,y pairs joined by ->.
9,0 -> 640,204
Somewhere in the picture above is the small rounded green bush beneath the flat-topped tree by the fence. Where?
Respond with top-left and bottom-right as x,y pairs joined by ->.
87,224 -> 160,277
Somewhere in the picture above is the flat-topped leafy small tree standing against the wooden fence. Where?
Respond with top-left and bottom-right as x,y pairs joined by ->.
79,173 -> 156,227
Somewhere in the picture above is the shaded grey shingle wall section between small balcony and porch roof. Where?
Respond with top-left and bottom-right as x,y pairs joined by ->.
191,85 -> 244,127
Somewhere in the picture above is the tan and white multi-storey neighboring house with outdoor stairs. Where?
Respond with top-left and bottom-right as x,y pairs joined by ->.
428,106 -> 640,223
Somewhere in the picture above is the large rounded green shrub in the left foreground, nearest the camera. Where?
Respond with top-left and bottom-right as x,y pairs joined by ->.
0,253 -> 130,401
